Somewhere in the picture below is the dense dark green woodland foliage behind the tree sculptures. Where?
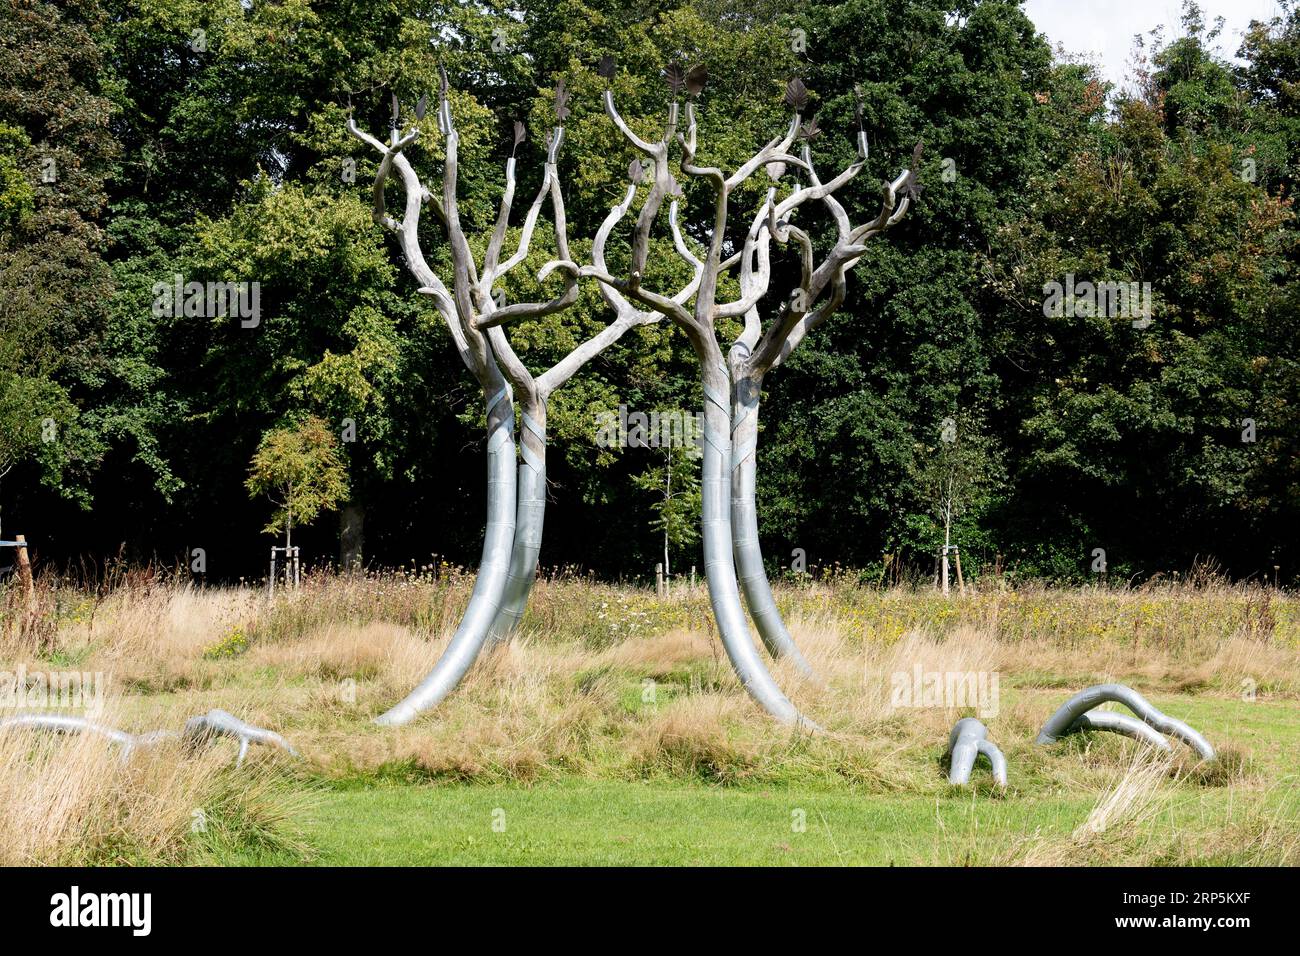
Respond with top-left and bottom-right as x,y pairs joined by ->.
0,0 -> 1300,579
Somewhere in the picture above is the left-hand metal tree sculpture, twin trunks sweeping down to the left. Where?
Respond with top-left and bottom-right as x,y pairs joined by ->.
348,73 -> 702,724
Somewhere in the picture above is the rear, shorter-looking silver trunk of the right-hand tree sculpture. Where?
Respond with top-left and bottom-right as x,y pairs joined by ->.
731,376 -> 814,678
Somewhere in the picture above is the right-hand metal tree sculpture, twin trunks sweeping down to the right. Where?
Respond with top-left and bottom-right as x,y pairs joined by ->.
581,65 -> 914,728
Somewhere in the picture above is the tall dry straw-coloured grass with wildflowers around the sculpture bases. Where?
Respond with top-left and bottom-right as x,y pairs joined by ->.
0,567 -> 1300,861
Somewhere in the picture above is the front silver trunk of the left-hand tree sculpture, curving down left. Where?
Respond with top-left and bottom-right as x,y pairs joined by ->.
374,385 -> 516,726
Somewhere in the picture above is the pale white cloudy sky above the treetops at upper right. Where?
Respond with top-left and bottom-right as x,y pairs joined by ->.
1024,0 -> 1281,86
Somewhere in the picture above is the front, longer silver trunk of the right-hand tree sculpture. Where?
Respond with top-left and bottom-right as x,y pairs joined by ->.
701,351 -> 820,730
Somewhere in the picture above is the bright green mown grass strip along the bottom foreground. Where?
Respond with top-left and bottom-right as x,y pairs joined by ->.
287,783 -> 1089,866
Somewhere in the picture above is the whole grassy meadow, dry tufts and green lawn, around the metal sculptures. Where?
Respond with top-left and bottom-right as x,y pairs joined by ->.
0,567 -> 1300,865
